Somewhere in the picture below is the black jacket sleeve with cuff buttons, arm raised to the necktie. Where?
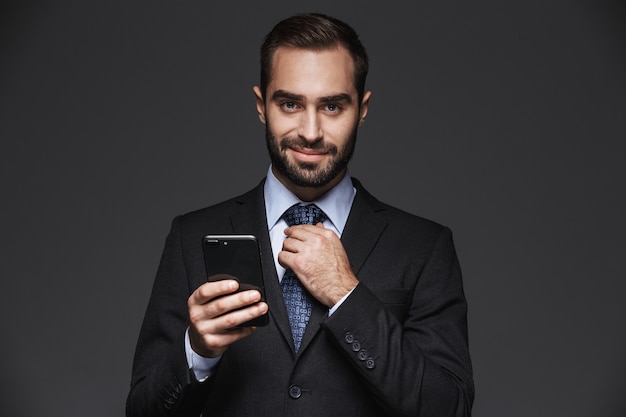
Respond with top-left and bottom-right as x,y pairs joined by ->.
322,227 -> 474,417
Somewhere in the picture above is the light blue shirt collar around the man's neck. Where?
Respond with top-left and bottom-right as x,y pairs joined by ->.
263,166 -> 356,235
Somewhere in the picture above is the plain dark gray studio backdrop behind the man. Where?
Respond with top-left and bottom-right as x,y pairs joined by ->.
0,0 -> 626,417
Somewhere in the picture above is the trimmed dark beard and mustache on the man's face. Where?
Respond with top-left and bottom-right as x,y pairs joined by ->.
265,123 -> 357,188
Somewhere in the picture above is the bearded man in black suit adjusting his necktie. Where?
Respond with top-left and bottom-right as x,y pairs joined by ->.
127,14 -> 474,417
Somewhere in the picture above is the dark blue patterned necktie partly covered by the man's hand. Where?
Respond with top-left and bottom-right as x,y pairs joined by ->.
280,204 -> 326,352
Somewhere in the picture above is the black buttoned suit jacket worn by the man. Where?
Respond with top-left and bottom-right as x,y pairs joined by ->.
127,179 -> 474,417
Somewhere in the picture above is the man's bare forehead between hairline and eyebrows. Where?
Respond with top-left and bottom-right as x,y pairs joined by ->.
268,46 -> 356,97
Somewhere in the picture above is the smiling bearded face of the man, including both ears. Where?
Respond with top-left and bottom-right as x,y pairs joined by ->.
254,47 -> 370,188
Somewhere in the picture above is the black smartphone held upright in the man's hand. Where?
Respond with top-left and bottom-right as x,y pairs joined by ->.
202,235 -> 268,326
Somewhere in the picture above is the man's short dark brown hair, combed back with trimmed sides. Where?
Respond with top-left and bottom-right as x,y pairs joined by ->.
261,13 -> 369,101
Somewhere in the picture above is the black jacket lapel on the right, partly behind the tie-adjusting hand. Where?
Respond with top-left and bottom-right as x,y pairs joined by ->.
298,178 -> 387,352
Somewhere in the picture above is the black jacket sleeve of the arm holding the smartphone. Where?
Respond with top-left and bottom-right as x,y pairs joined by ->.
126,217 -> 211,417
